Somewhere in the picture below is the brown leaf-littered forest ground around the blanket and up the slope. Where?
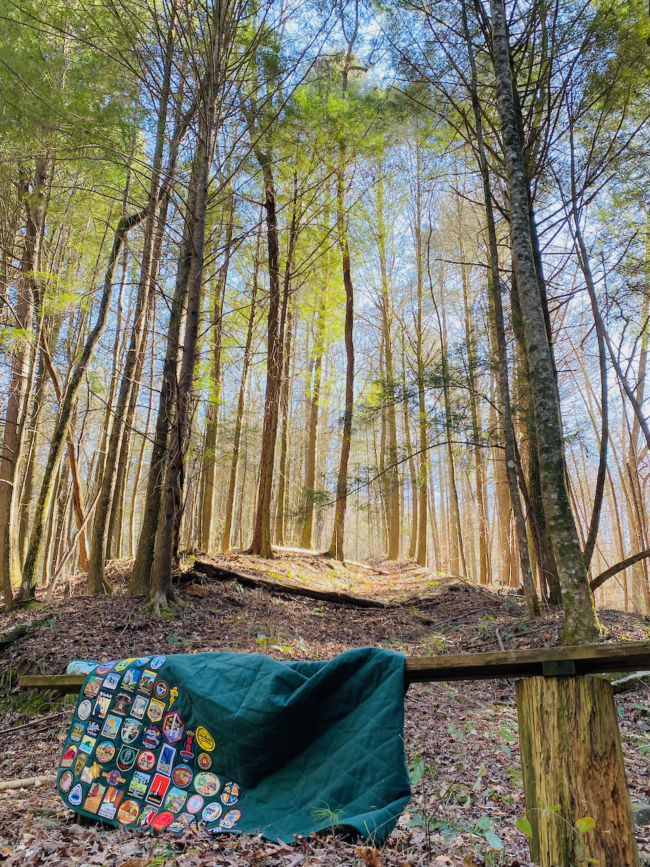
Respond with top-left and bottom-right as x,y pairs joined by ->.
0,551 -> 650,867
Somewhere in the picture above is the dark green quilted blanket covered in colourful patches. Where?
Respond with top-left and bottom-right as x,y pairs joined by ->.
57,647 -> 410,845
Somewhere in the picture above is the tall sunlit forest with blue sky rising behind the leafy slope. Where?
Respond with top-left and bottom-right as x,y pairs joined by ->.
0,0 -> 650,644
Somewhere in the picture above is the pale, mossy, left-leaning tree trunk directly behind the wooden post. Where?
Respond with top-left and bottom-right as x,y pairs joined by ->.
490,0 -> 599,644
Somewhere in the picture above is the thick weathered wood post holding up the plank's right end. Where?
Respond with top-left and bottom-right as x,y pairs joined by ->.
516,661 -> 639,867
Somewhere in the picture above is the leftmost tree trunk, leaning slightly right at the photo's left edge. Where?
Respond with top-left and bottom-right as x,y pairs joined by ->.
0,159 -> 49,611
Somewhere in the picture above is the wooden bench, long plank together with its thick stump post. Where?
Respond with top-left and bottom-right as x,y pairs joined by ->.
18,641 -> 650,867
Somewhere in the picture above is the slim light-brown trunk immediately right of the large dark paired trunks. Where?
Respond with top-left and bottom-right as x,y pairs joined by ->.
199,194 -> 235,551
